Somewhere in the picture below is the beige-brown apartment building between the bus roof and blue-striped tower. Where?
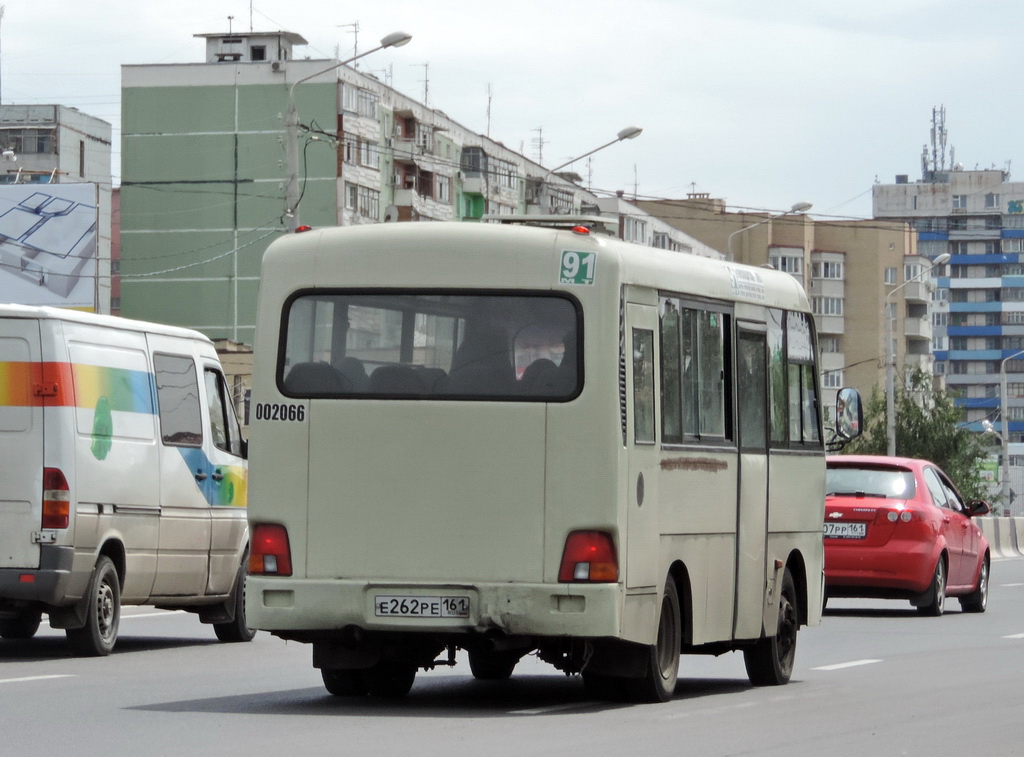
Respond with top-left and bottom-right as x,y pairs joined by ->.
637,195 -> 933,408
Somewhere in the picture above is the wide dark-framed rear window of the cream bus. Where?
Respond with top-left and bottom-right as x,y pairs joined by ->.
278,291 -> 582,402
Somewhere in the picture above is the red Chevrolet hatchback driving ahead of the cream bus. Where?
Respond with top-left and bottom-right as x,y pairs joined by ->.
824,455 -> 989,616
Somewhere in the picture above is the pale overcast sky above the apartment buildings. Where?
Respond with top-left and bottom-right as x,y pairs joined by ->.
0,0 -> 1024,219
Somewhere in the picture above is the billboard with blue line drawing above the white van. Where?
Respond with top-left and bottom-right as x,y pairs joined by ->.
0,183 -> 98,310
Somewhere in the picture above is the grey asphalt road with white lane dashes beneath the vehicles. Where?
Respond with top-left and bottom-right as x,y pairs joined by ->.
0,559 -> 1024,757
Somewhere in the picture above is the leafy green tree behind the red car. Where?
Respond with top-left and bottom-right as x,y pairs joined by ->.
843,369 -> 990,500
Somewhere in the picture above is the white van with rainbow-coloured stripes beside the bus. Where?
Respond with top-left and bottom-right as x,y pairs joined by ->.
0,304 -> 253,655
